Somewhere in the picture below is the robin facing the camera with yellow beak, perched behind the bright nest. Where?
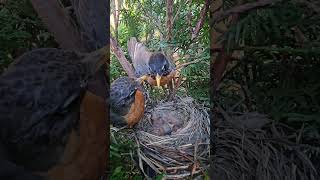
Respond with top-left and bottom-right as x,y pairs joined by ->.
128,37 -> 175,87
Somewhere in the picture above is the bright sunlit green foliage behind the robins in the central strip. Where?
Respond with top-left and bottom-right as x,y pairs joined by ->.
110,0 -> 210,101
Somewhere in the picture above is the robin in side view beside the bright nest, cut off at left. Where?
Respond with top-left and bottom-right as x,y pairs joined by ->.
110,77 -> 145,128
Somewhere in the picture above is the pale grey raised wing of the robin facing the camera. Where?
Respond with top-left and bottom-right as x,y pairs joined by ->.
128,37 -> 152,77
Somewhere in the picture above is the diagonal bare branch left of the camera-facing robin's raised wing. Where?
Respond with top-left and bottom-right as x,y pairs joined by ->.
110,36 -> 136,78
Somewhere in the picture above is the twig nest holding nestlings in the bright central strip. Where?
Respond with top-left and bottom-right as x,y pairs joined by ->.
135,97 -> 210,179
